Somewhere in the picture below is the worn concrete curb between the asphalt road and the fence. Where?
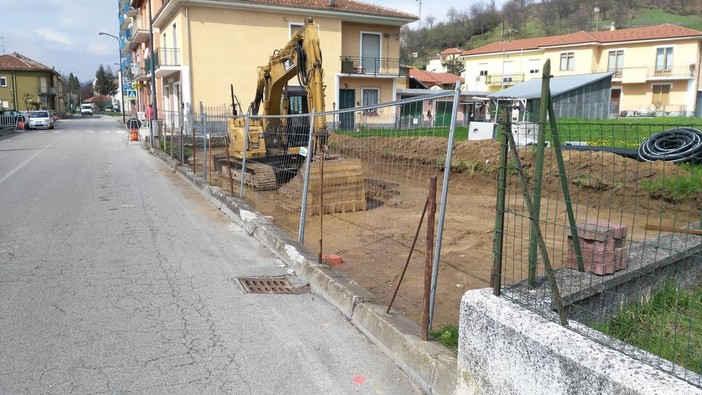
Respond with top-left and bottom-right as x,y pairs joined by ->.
155,151 -> 458,394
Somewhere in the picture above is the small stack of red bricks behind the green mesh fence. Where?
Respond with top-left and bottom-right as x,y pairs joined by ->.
566,222 -> 629,276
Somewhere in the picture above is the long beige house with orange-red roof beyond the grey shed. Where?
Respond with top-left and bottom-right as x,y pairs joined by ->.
461,24 -> 702,116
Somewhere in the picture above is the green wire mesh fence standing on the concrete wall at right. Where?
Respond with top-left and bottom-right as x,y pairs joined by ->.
493,113 -> 702,386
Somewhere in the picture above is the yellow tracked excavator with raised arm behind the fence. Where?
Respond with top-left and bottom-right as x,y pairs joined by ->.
227,18 -> 366,212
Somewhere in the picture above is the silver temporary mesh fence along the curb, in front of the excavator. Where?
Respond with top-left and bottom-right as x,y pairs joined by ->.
151,92 -> 464,332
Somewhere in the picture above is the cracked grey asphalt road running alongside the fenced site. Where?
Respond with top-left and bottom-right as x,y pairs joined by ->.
0,117 -> 419,394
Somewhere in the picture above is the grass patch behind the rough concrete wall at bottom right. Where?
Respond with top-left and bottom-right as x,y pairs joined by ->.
594,283 -> 702,374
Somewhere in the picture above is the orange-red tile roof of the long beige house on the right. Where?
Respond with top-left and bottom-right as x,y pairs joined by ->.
462,23 -> 702,56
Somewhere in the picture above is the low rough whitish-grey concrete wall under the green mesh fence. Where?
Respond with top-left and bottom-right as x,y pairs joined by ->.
457,289 -> 702,395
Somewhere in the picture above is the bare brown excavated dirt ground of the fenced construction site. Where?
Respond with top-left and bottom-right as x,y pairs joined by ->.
206,136 -> 702,327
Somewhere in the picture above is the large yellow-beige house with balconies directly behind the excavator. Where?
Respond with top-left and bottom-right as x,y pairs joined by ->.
120,0 -> 417,127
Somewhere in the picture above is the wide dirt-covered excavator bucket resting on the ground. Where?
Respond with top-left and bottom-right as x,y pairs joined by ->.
300,159 -> 366,215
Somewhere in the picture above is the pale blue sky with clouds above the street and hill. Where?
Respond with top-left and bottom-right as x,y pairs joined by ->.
0,0 -> 505,82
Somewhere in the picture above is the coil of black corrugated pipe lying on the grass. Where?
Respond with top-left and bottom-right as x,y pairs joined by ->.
638,127 -> 702,163
